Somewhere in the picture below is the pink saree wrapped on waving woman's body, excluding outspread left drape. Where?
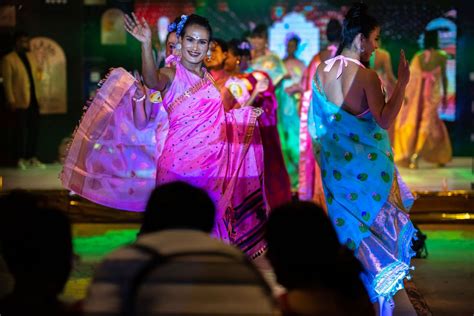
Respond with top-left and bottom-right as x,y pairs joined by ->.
156,63 -> 267,256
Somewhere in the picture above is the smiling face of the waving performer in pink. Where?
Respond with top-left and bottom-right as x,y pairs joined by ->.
179,24 -> 209,64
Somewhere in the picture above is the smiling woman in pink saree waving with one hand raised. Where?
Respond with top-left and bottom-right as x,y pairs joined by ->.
62,15 -> 268,257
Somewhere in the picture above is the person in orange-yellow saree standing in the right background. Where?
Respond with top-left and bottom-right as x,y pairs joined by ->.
393,31 -> 452,169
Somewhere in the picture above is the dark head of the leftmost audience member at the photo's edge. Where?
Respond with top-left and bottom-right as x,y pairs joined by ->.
0,190 -> 73,297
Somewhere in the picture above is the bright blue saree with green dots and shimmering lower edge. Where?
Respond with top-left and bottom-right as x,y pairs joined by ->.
308,65 -> 415,301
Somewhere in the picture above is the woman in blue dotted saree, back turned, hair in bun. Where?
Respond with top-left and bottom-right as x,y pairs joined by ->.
308,4 -> 415,315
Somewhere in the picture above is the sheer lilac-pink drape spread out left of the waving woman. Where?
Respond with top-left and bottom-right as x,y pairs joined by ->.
60,68 -> 162,211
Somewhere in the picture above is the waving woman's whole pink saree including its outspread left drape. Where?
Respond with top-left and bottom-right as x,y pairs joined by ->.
62,62 -> 268,257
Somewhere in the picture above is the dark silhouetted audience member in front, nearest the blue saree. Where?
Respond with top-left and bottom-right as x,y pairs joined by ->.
266,202 -> 375,316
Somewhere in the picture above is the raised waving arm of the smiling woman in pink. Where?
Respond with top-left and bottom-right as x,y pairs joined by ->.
124,12 -> 174,91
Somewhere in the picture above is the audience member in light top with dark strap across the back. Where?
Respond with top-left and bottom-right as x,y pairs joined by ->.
84,182 -> 276,315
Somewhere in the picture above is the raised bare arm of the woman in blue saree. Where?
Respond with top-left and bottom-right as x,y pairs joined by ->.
365,50 -> 410,129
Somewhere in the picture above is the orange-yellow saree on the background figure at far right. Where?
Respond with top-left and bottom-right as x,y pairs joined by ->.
393,53 -> 452,167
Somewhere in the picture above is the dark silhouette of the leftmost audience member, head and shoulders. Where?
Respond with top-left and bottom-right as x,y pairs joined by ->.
0,191 -> 74,316
